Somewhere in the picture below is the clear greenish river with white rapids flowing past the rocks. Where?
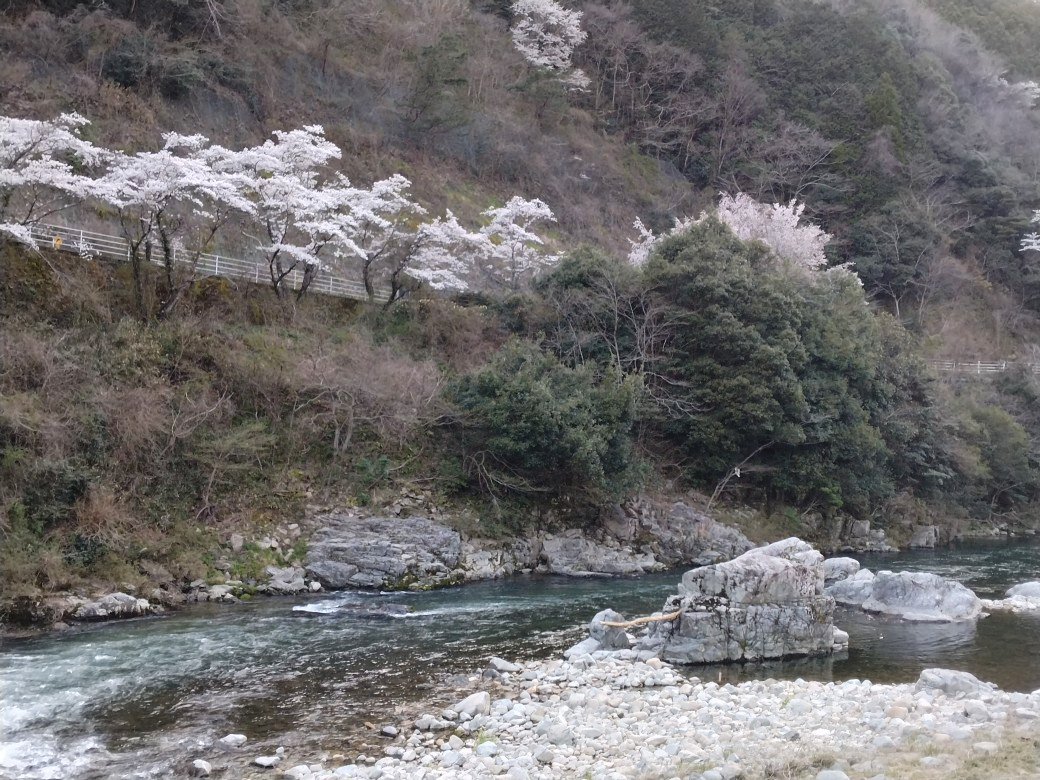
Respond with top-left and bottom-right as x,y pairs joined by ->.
0,540 -> 1040,780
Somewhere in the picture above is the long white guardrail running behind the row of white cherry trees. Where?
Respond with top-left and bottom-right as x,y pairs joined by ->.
30,224 -> 387,302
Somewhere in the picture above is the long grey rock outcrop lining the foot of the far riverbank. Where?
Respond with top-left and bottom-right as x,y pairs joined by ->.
303,502 -> 752,593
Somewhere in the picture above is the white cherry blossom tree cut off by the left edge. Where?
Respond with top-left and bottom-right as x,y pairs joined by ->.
0,113 -> 108,246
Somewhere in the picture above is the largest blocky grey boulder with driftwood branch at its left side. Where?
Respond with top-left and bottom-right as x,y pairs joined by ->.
641,538 -> 834,664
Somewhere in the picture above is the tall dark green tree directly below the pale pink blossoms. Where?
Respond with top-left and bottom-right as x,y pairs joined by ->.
647,219 -> 809,479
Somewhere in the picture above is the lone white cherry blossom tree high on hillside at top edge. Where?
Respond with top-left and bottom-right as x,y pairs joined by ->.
513,0 -> 589,89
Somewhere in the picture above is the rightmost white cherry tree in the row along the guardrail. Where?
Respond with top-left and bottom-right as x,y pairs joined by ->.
480,196 -> 560,290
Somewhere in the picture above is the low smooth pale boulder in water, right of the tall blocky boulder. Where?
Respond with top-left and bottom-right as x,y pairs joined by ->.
862,571 -> 982,622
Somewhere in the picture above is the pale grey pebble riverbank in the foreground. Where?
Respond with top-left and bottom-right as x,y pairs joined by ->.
213,655 -> 1040,780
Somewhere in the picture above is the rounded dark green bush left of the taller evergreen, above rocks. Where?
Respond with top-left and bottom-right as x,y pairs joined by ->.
452,341 -> 642,500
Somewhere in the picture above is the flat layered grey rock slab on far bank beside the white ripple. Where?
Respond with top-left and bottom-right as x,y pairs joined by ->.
305,513 -> 462,590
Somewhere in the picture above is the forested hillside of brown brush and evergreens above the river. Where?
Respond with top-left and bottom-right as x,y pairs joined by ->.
0,0 -> 1040,607
